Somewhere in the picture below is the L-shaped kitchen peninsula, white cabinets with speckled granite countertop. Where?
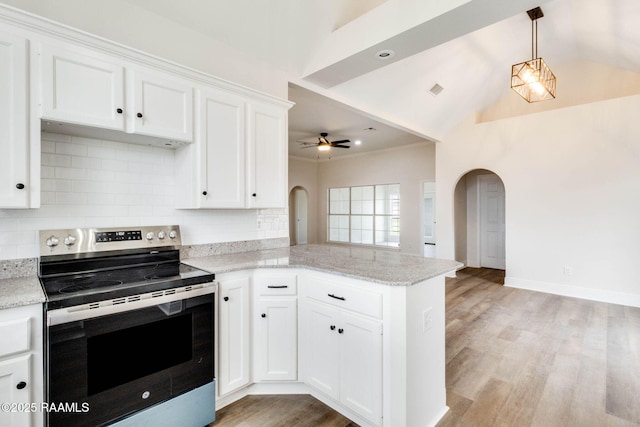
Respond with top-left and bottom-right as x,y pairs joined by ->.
183,245 -> 462,426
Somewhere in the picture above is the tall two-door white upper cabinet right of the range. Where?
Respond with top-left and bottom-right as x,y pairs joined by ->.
176,88 -> 288,209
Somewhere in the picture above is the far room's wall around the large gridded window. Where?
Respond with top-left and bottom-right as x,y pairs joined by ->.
316,143 -> 440,255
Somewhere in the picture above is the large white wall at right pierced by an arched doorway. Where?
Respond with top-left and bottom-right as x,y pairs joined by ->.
436,95 -> 640,306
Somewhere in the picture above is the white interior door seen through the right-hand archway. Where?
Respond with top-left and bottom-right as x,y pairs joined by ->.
478,175 -> 505,270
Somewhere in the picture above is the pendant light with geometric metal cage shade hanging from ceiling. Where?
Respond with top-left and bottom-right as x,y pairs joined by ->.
511,7 -> 556,102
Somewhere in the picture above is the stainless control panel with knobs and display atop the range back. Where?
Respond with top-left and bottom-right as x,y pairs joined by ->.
40,225 -> 182,256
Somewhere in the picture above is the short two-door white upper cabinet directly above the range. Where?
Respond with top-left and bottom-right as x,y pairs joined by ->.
40,44 -> 193,142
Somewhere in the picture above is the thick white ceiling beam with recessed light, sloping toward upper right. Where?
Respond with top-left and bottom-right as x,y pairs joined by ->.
303,0 -> 550,88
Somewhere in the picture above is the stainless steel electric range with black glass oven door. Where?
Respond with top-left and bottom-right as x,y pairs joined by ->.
39,226 -> 216,427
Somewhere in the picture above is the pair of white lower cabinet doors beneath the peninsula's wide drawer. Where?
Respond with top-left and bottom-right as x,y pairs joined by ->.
302,299 -> 383,425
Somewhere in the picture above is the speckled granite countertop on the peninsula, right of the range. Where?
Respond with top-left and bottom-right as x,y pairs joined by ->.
182,245 -> 463,286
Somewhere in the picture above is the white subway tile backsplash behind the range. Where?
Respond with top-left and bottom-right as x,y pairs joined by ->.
0,134 -> 289,259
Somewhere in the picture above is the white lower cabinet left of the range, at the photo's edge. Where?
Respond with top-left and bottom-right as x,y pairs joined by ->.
0,304 -> 44,427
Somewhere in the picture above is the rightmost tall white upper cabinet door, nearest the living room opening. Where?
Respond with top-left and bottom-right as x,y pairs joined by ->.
247,102 -> 287,208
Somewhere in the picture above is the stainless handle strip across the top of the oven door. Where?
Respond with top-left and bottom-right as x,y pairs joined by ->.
47,282 -> 217,326
